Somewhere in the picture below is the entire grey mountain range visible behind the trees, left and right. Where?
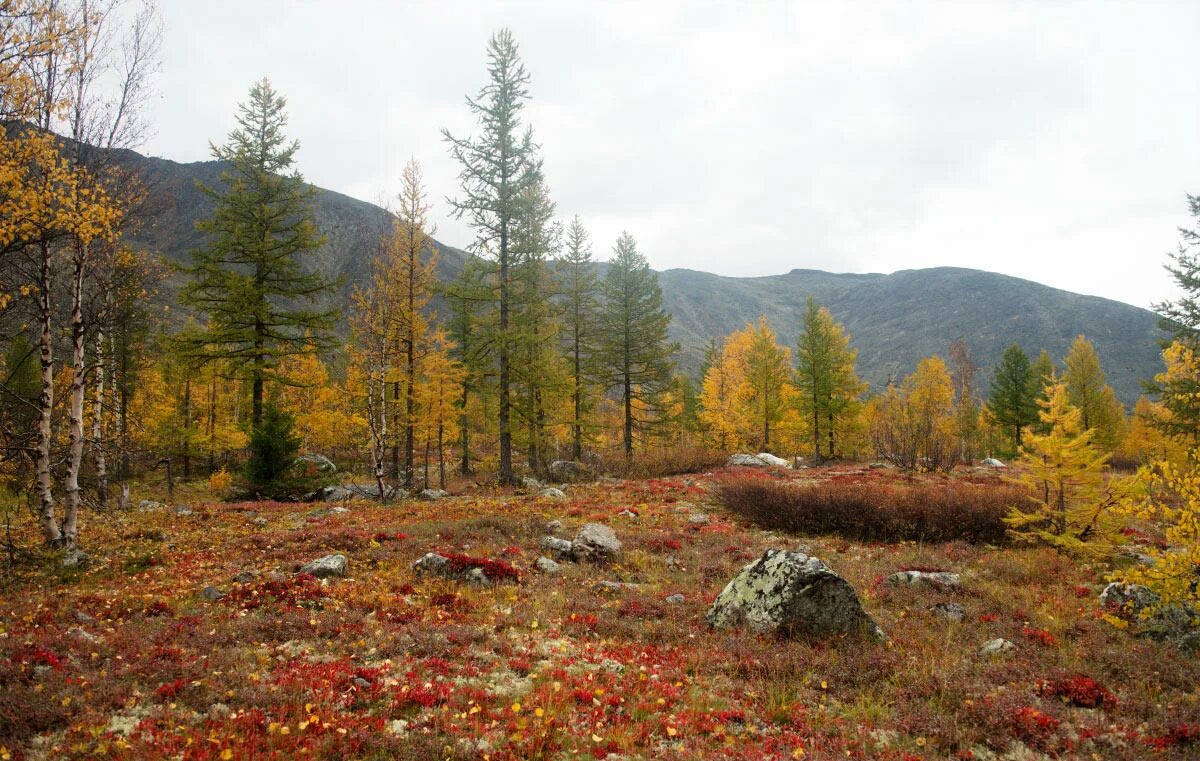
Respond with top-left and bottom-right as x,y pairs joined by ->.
120,151 -> 1160,406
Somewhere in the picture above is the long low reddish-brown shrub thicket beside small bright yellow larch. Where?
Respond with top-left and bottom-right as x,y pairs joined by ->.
718,478 -> 1028,544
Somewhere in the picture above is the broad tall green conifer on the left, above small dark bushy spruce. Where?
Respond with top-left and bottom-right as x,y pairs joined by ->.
180,79 -> 337,426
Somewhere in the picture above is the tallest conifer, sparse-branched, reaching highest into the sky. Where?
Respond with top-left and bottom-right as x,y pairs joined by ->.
443,29 -> 541,484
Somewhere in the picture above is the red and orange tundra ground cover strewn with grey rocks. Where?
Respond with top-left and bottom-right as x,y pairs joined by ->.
0,467 -> 1200,761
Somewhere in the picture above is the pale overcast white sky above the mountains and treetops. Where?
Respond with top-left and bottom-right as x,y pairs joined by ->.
143,0 -> 1200,306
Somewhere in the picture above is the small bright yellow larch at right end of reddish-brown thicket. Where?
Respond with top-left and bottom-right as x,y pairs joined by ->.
1004,382 -> 1122,556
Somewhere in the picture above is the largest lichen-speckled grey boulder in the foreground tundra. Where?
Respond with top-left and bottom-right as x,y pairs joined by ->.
704,550 -> 883,640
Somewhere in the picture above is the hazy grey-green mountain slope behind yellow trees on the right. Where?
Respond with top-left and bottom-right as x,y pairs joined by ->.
659,266 -> 1160,405
